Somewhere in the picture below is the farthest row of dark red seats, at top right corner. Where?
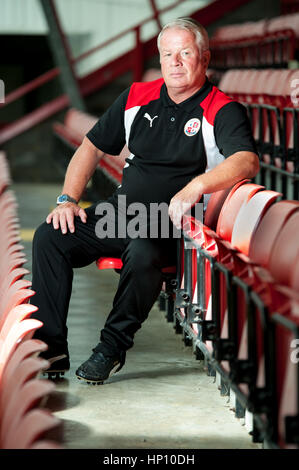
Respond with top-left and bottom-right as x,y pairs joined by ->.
210,13 -> 299,68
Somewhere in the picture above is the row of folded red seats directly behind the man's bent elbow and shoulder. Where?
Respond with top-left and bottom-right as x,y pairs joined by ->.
219,69 -> 299,199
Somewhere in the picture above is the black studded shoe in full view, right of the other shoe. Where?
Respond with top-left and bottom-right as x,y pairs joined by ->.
76,348 -> 125,385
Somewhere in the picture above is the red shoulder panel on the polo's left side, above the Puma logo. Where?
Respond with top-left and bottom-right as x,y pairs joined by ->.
126,78 -> 164,110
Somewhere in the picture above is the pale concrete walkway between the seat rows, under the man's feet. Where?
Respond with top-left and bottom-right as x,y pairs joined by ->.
13,184 -> 261,449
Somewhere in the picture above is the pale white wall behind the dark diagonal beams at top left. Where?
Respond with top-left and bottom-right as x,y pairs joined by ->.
0,0 -> 211,76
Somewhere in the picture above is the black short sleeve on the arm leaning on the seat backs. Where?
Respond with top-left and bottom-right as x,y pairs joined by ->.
214,101 -> 257,158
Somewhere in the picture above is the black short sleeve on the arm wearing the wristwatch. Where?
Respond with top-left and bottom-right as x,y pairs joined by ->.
86,88 -> 129,155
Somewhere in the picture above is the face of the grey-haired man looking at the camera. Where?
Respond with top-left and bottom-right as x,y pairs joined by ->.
160,28 -> 210,96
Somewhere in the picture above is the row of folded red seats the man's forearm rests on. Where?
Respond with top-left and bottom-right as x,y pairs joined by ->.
170,180 -> 299,448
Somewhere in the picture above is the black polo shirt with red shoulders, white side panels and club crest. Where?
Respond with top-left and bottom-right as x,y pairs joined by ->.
87,78 -> 256,209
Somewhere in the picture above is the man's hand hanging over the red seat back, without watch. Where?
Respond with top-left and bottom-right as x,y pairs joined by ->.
168,181 -> 202,229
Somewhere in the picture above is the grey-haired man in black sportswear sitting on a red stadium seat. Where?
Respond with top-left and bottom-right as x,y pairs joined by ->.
32,18 -> 259,383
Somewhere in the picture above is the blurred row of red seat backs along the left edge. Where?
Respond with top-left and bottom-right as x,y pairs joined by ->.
0,152 -> 61,449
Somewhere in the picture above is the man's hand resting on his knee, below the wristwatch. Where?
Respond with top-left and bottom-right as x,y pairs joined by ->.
46,202 -> 87,234
